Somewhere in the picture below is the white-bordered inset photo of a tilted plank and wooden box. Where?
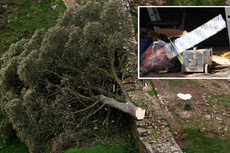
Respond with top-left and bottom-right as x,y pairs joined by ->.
138,6 -> 230,79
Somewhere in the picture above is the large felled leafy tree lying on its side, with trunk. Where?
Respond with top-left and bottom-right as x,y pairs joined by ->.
0,0 -> 145,153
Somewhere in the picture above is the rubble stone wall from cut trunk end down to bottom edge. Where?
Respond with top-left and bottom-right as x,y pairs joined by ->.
130,83 -> 182,153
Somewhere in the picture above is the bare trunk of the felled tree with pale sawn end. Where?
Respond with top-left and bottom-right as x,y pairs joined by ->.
96,95 -> 145,120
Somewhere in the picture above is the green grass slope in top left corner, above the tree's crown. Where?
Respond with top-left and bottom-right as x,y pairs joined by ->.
0,0 -> 67,53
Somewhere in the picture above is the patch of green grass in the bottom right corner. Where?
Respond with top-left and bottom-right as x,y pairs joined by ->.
182,129 -> 230,153
